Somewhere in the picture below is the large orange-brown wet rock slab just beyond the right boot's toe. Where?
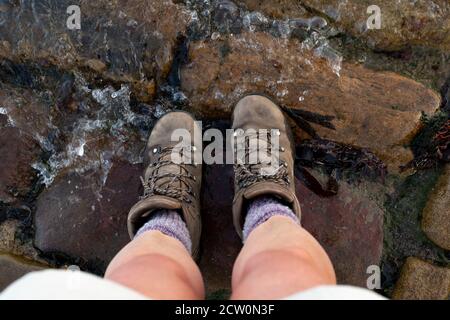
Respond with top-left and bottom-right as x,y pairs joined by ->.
181,33 -> 440,169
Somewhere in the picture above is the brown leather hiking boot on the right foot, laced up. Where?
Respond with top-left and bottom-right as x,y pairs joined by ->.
232,95 -> 301,238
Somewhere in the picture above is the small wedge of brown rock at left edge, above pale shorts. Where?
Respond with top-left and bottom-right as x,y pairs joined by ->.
0,254 -> 48,292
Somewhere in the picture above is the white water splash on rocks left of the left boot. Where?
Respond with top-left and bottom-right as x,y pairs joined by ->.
33,81 -> 151,187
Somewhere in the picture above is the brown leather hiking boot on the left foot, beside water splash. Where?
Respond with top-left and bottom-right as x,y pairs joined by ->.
128,112 -> 202,258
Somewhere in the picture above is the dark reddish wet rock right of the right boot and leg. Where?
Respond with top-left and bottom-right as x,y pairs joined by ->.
296,176 -> 383,287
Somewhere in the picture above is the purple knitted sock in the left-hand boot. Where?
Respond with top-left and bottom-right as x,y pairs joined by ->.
134,210 -> 192,253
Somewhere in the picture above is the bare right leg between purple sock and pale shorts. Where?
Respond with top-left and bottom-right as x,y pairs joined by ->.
232,216 -> 336,299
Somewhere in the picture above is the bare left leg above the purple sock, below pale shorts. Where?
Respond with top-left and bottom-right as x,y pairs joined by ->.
105,231 -> 205,300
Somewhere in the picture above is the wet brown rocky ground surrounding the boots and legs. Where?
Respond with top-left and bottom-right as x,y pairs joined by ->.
0,0 -> 450,299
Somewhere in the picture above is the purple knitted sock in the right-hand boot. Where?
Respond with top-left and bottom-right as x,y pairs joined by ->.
243,196 -> 300,242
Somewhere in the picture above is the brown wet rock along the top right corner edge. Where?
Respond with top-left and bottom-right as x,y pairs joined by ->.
242,0 -> 450,50
